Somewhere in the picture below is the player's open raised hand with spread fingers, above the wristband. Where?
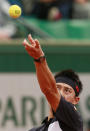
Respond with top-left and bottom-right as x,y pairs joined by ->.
23,34 -> 44,59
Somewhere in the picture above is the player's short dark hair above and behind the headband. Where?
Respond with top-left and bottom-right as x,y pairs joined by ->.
54,69 -> 83,95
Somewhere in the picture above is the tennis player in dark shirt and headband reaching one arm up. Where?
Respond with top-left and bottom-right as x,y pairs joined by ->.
23,35 -> 83,131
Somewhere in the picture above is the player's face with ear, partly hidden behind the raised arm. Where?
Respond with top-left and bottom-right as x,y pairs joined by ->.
56,83 -> 79,104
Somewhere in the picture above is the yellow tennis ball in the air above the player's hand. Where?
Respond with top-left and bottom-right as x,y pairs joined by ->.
9,5 -> 22,19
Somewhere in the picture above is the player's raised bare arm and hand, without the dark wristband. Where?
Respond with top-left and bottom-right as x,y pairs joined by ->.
23,35 -> 61,111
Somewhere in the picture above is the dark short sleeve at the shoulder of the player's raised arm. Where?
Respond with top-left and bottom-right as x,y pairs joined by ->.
54,97 -> 82,127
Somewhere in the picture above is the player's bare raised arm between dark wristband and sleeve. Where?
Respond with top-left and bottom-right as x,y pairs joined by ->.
35,60 -> 60,111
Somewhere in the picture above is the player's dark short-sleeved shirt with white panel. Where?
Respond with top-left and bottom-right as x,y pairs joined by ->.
29,97 -> 83,131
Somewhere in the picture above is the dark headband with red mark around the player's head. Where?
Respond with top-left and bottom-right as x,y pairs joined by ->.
55,77 -> 79,96
